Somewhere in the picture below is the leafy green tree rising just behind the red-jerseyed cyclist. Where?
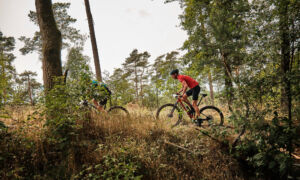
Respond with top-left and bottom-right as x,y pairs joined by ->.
180,0 -> 249,107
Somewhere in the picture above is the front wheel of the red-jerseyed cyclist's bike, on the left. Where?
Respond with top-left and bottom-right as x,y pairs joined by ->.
156,104 -> 182,127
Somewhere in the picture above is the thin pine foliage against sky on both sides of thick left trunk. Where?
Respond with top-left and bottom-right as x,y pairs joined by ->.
19,3 -> 86,55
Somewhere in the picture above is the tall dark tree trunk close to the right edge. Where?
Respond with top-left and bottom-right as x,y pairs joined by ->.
279,0 -> 292,120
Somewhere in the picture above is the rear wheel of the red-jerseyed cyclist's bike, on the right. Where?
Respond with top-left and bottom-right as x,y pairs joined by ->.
200,106 -> 224,127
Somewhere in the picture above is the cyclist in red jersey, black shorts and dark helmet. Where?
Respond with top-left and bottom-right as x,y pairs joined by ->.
170,69 -> 200,121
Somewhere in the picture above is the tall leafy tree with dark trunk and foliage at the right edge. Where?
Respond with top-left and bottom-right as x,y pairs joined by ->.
251,0 -> 300,118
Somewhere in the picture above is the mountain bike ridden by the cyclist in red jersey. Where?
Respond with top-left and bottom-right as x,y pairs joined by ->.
156,94 -> 224,127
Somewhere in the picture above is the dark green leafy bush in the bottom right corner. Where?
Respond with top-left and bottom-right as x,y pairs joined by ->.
236,116 -> 299,178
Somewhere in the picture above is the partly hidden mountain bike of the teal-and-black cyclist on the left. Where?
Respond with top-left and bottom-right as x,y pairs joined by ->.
80,100 -> 129,117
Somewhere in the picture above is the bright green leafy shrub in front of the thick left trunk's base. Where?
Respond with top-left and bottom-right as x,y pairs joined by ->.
44,79 -> 79,149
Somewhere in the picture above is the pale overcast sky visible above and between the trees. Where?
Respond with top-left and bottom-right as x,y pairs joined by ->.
0,0 -> 187,82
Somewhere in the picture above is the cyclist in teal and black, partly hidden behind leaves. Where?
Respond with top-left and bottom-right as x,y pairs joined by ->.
91,80 -> 111,111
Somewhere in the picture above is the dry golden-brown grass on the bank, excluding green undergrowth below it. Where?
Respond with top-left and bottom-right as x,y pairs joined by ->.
0,108 -> 244,179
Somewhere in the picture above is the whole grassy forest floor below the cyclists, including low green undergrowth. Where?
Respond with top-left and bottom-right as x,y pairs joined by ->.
0,107 -> 298,180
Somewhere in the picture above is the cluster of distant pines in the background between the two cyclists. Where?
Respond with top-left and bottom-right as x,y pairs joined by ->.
104,49 -> 182,108
